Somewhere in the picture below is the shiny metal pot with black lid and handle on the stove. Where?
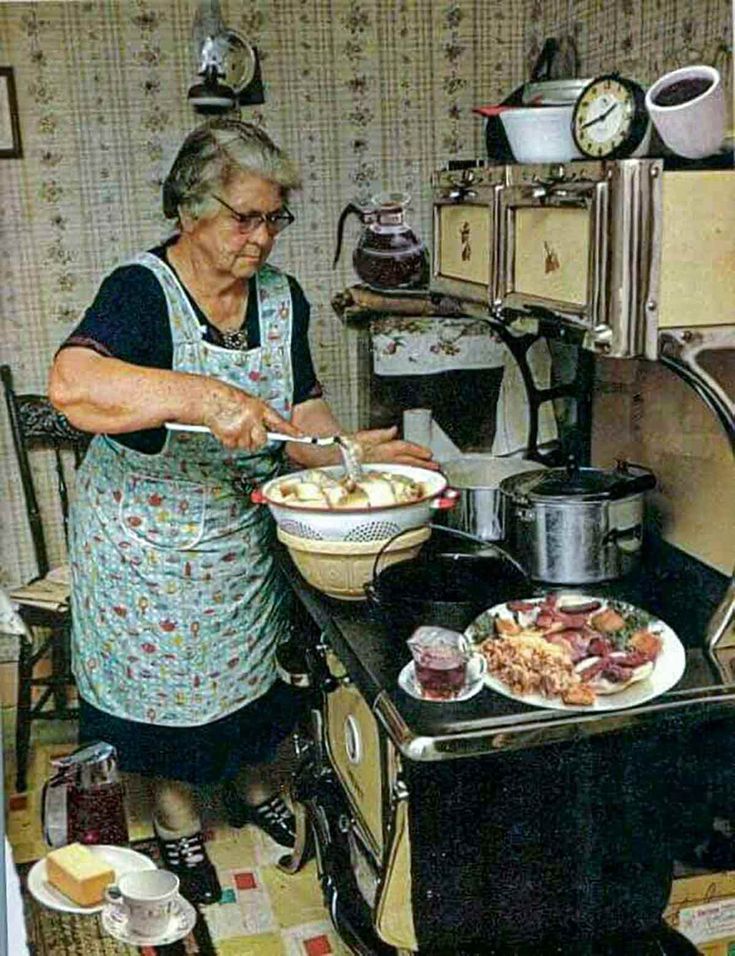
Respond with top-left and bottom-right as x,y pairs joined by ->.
500,465 -> 656,584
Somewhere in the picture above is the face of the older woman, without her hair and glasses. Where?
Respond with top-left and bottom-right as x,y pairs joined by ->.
184,173 -> 283,279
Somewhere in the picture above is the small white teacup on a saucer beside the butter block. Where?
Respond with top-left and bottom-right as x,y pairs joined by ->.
105,870 -> 179,938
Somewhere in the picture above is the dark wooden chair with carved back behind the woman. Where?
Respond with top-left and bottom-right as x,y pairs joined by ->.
0,365 -> 92,791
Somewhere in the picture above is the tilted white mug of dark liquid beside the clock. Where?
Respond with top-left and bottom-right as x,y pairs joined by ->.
646,65 -> 725,159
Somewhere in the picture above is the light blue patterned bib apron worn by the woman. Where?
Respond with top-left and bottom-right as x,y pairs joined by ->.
70,253 -> 293,727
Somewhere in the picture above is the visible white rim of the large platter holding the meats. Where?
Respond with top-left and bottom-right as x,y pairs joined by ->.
465,594 -> 686,713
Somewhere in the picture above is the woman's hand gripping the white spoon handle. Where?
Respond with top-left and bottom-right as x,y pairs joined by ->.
202,382 -> 303,451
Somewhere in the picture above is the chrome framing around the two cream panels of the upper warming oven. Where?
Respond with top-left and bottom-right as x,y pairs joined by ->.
432,159 -> 664,361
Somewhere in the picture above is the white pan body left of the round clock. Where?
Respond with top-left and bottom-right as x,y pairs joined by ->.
500,104 -> 582,163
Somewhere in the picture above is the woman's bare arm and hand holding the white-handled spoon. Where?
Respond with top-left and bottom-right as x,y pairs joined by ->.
49,347 -> 300,450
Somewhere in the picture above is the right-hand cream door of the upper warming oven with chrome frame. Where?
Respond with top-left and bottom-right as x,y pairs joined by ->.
492,159 -> 663,358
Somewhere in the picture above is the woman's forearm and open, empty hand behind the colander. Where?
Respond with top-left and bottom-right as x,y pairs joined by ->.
286,398 -> 439,470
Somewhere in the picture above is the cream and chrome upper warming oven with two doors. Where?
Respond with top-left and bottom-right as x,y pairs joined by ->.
431,159 -> 735,359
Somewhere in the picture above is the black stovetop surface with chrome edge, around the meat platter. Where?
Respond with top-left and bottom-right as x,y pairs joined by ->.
283,540 -> 735,761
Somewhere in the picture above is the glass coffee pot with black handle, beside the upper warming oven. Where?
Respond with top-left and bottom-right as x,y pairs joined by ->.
333,193 -> 429,290
